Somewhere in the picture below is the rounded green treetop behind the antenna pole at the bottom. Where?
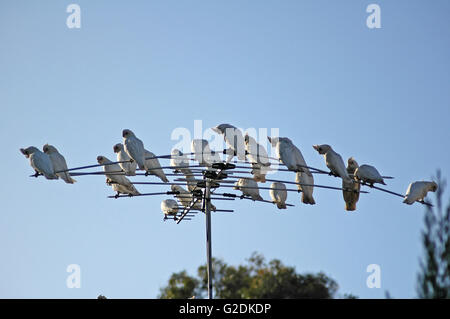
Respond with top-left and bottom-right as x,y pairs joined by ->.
159,253 -> 340,299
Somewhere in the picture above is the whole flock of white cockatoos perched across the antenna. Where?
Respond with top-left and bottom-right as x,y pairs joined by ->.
20,124 -> 437,216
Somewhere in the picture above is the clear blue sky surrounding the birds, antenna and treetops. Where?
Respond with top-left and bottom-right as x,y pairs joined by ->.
0,0 -> 450,298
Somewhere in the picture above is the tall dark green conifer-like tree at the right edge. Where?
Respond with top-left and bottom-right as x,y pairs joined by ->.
417,171 -> 450,299
